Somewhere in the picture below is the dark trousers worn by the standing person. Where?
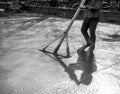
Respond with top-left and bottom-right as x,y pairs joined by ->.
81,18 -> 99,43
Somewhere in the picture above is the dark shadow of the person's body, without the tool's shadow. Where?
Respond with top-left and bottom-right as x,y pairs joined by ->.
69,46 -> 97,85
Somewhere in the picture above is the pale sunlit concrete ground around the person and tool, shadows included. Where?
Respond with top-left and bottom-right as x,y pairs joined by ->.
0,14 -> 120,94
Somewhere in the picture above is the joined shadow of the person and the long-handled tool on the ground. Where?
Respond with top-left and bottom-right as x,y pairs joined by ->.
39,47 -> 97,85
